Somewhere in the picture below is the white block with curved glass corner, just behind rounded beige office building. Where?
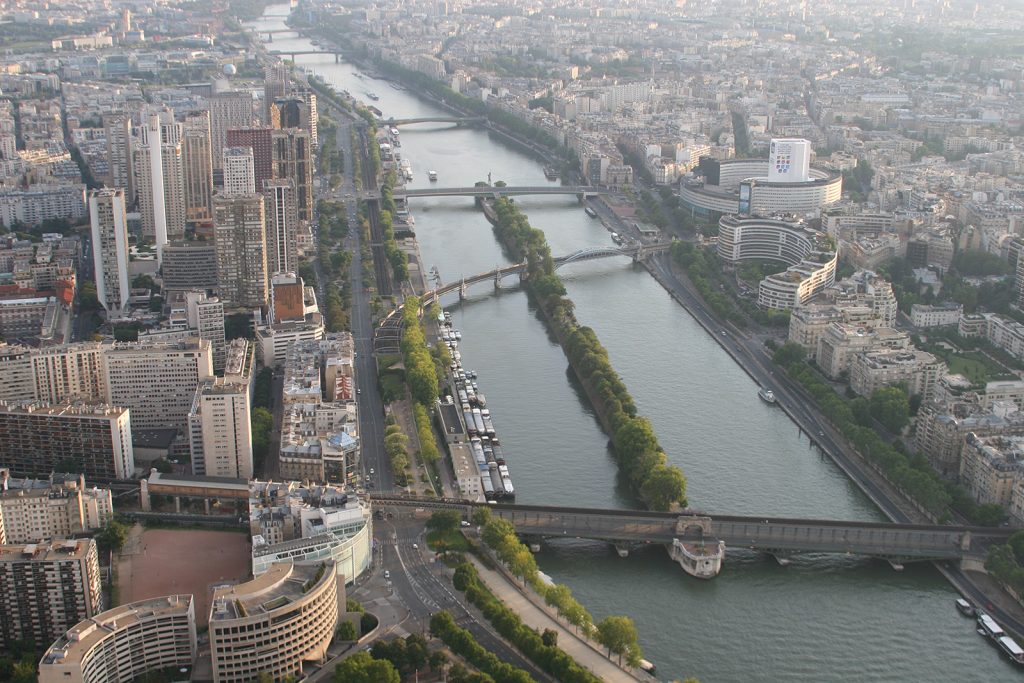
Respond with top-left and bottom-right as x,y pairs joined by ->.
249,481 -> 374,584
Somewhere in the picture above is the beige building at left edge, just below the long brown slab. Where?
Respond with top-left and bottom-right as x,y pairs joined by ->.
0,467 -> 114,544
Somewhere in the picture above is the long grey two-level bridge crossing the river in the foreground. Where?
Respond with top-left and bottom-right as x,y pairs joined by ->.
371,494 -> 1013,573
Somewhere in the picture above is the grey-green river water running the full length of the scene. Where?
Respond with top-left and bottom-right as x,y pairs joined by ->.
247,5 -> 1016,683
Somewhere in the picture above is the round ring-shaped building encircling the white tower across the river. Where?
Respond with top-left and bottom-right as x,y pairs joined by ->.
679,159 -> 843,219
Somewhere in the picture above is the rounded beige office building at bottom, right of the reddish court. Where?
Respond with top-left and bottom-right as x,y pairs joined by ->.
210,560 -> 337,683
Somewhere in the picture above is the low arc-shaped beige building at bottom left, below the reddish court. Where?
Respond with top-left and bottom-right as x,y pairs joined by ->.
39,595 -> 197,683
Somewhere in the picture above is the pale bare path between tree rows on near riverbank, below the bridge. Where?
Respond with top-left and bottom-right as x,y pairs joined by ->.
468,556 -> 651,682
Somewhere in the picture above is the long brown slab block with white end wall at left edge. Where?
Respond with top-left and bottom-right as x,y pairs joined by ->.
0,402 -> 135,481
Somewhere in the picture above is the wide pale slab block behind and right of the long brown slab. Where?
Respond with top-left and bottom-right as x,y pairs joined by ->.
102,337 -> 213,429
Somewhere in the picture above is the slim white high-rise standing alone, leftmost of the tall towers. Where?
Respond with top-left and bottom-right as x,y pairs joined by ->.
89,188 -> 131,319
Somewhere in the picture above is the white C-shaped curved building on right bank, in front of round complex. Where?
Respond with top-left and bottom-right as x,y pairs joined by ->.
718,216 -> 839,309
